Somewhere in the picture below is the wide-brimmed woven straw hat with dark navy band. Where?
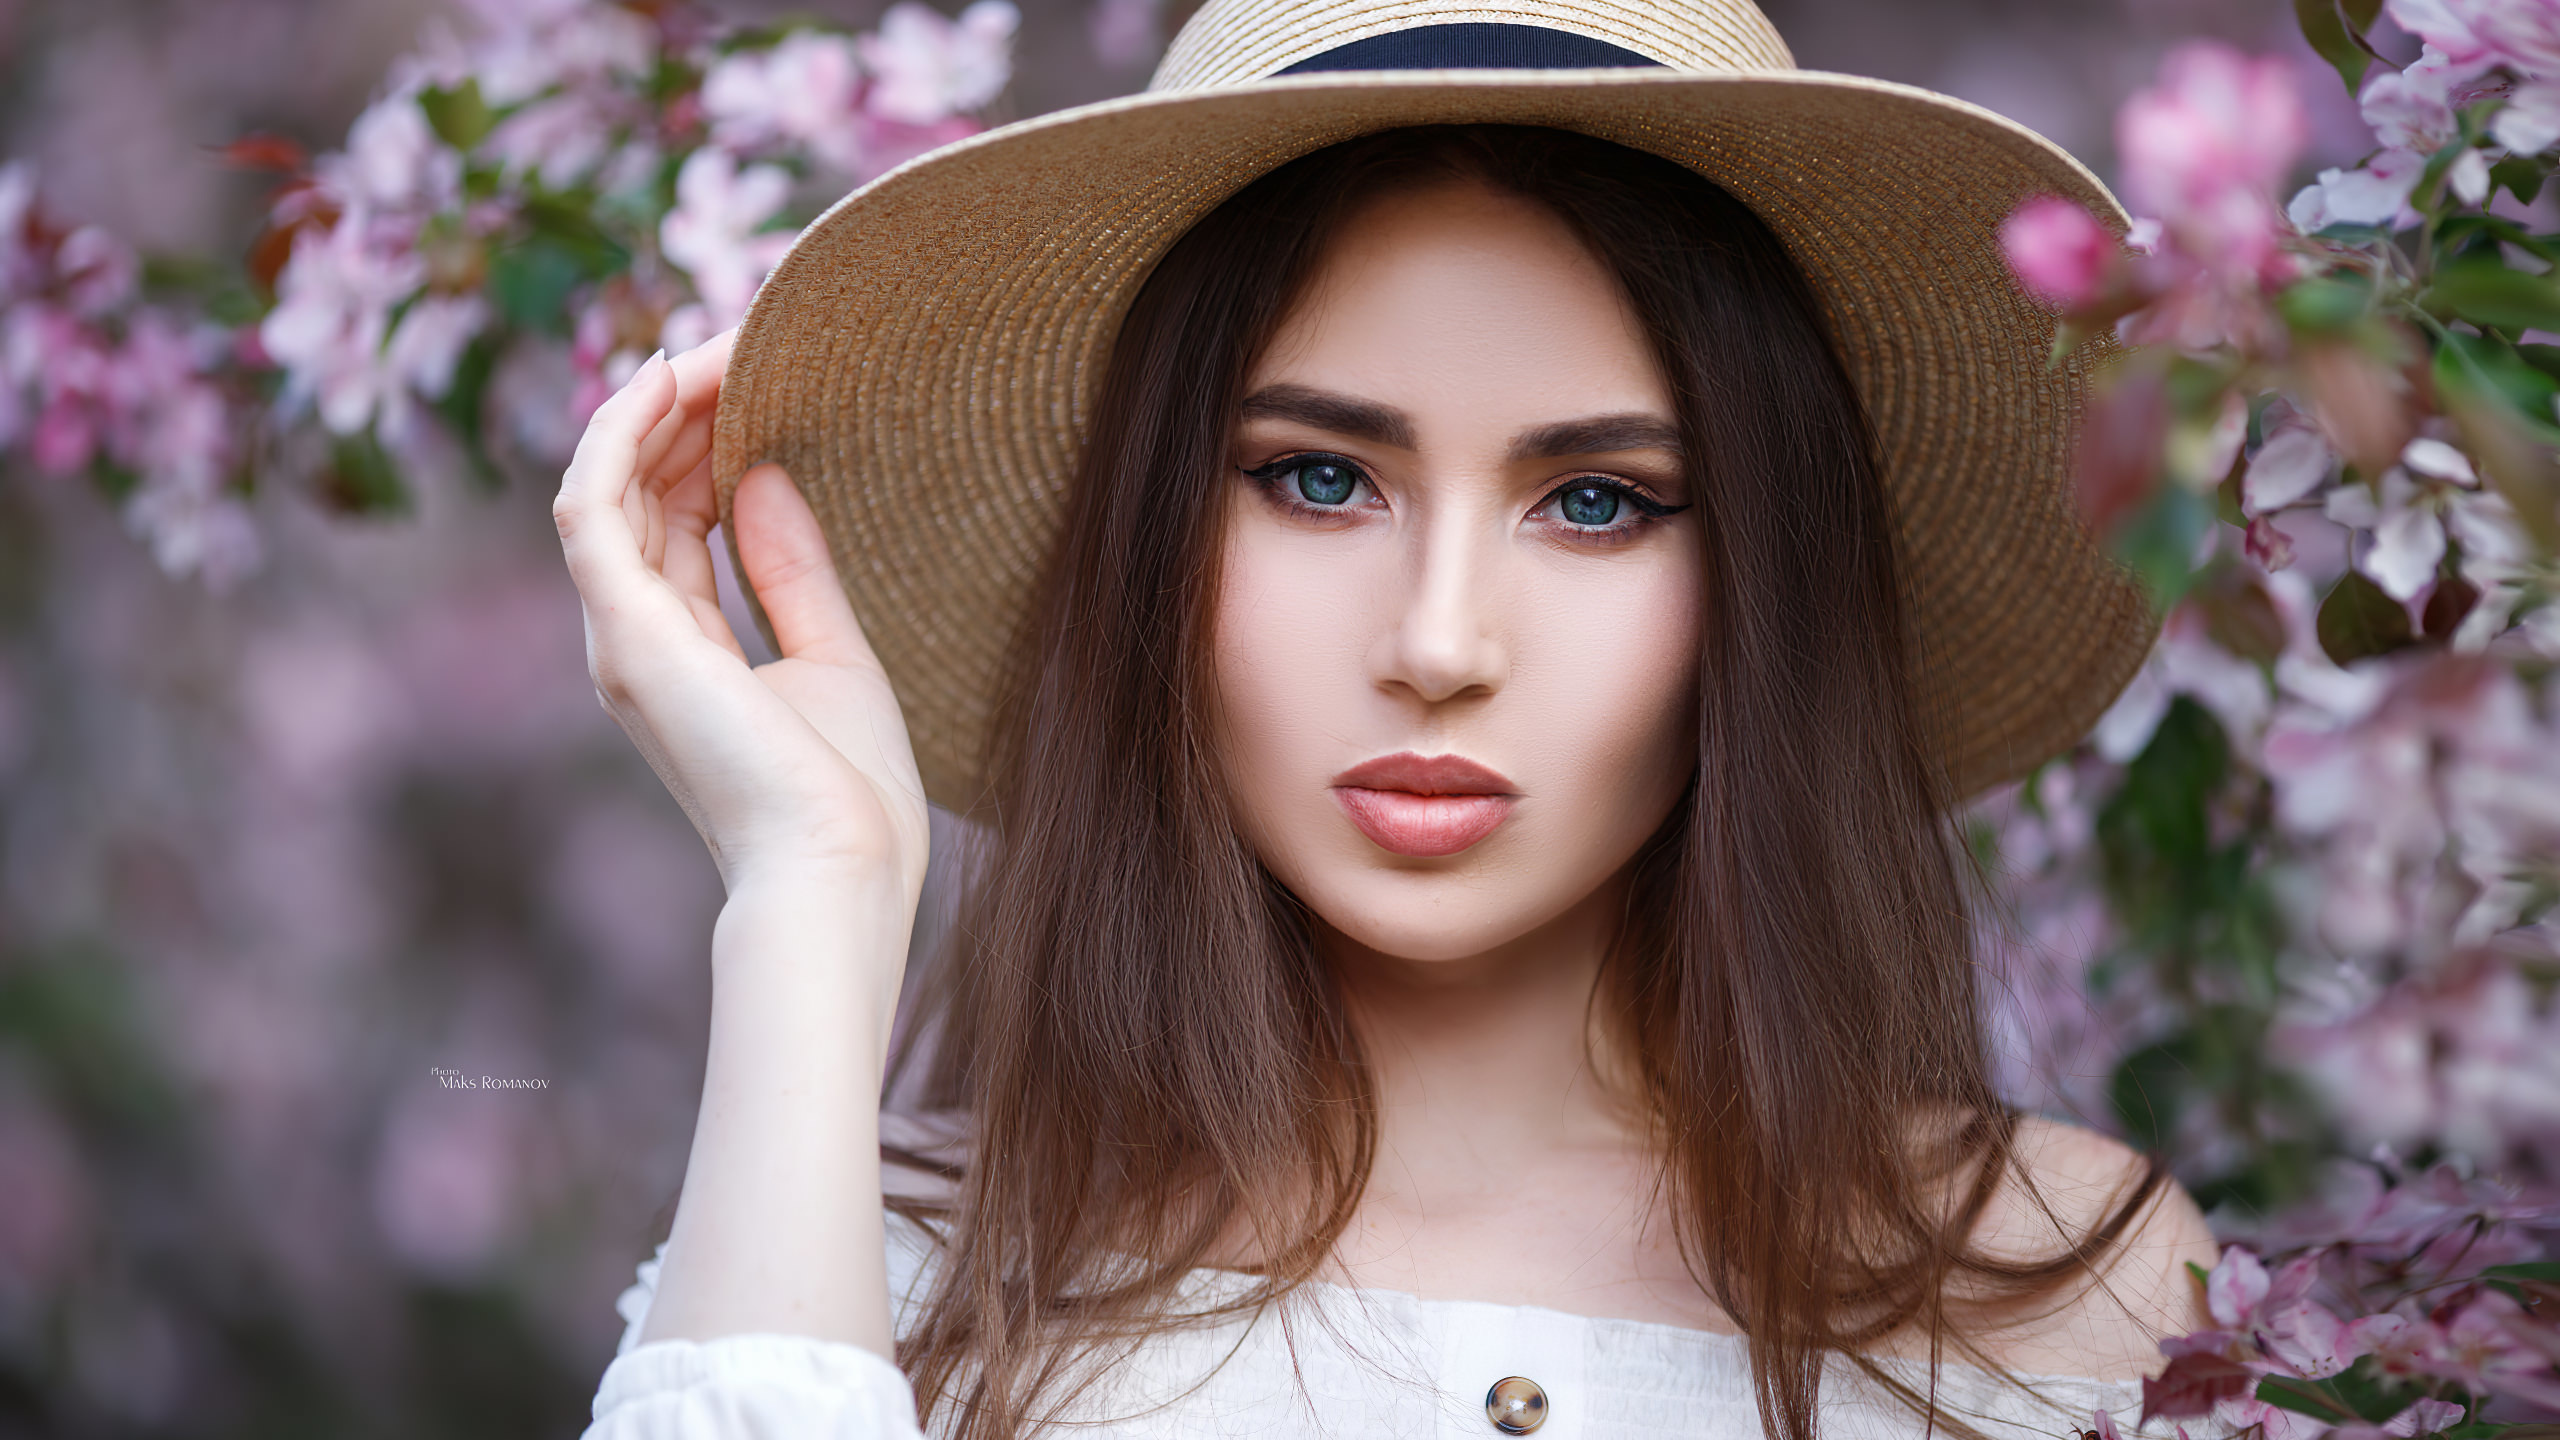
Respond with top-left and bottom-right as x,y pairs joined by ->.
712,0 -> 2153,807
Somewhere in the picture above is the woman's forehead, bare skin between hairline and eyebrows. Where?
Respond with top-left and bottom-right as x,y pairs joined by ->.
1247,182 -> 1669,425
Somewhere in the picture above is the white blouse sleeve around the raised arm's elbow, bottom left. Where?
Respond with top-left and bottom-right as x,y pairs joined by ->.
586,1245 -> 922,1440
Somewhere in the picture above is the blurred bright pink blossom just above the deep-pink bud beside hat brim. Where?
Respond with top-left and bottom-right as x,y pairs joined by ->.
2115,41 -> 2309,274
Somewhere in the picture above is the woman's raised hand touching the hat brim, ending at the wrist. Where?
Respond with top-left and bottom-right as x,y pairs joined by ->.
550,331 -> 927,901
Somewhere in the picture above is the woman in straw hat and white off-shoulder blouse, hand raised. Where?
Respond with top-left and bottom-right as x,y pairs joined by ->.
556,0 -> 2212,1440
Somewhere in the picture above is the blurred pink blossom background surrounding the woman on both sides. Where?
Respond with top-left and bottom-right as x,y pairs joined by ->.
0,0 -> 2560,1437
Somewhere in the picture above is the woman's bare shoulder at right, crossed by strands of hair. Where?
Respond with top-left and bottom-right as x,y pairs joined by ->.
1974,1117 -> 2217,1379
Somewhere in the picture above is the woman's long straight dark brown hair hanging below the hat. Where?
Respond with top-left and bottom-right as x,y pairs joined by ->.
901,126 -> 2158,1440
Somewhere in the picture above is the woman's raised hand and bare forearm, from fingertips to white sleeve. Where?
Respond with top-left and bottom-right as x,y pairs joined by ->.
550,336 -> 927,1355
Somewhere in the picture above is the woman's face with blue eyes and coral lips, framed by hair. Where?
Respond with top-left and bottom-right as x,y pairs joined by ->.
1216,182 -> 1702,961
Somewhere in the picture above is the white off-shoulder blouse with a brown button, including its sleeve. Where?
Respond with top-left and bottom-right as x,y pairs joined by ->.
586,1199 -> 2143,1440
